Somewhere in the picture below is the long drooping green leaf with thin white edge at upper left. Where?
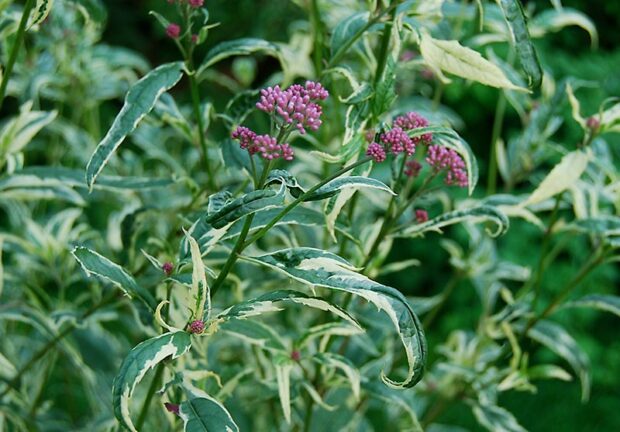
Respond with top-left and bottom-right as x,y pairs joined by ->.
86,62 -> 183,189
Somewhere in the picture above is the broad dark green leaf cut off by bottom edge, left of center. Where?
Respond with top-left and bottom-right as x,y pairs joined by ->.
179,397 -> 239,432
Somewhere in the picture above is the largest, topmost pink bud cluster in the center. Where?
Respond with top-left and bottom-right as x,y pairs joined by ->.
256,81 -> 329,134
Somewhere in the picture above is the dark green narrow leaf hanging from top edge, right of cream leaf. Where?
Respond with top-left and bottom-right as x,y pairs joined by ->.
497,0 -> 543,88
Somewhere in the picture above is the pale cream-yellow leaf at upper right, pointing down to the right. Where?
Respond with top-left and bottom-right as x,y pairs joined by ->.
420,31 -> 525,91
